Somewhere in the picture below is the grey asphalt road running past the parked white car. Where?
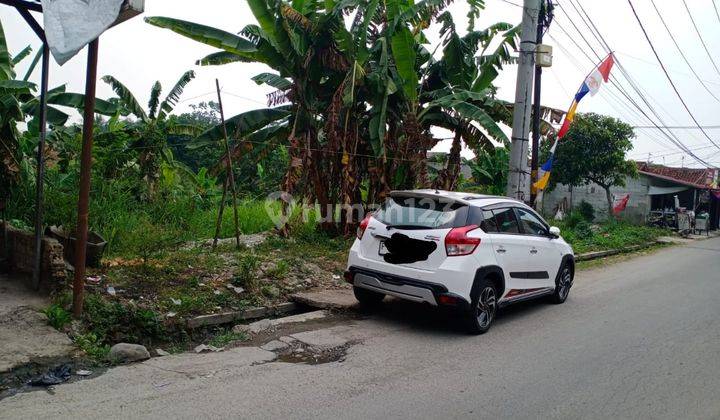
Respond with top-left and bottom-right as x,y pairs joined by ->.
0,238 -> 720,419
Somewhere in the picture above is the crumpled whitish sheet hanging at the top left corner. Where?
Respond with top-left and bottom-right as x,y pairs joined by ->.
42,0 -> 123,65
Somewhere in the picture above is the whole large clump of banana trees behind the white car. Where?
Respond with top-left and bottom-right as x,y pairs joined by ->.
146,0 -> 514,232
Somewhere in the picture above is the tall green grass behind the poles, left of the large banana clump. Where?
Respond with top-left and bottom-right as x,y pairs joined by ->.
8,174 -> 274,256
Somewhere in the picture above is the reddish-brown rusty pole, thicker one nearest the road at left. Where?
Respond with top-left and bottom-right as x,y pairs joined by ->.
73,39 -> 98,318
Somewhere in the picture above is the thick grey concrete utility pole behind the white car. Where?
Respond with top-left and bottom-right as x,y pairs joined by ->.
507,0 -> 541,201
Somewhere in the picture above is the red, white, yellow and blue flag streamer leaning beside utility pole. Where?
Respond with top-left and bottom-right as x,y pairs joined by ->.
533,53 -> 615,190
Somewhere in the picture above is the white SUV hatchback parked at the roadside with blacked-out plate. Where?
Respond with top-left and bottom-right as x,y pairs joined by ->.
345,190 -> 575,334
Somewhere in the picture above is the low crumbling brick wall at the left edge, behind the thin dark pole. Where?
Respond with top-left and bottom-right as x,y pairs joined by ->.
0,223 -> 66,290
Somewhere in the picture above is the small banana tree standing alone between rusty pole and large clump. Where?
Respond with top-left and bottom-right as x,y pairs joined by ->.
102,70 -> 198,200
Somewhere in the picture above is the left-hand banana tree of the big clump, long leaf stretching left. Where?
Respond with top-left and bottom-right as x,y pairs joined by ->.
146,0 -> 358,231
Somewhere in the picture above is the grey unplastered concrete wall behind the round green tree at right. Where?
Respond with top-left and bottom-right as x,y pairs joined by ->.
542,175 -> 650,223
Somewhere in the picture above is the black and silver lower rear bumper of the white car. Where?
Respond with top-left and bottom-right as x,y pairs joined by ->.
345,266 -> 470,309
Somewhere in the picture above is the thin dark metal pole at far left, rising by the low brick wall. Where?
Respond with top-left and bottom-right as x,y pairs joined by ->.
33,41 -> 50,290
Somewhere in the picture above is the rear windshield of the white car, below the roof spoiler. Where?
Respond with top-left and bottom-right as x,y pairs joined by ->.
373,196 -> 467,229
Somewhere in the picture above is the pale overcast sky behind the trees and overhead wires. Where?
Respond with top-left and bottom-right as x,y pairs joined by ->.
0,0 -> 720,166
